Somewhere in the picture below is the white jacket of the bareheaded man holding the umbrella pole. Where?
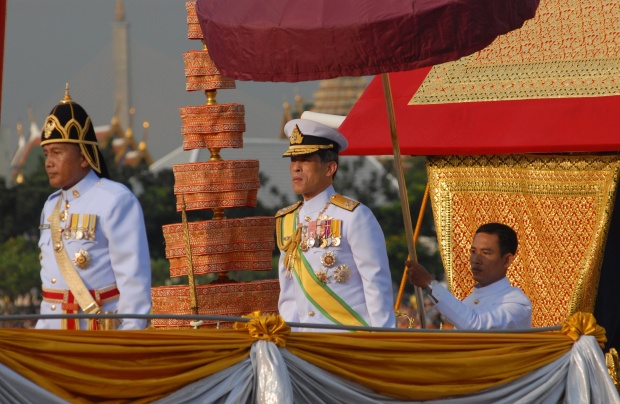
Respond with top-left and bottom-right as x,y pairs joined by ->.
432,277 -> 532,330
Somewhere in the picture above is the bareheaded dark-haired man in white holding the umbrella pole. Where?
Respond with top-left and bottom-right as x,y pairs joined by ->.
406,223 -> 532,330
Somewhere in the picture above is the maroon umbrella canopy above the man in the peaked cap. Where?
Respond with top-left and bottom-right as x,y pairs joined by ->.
196,0 -> 539,82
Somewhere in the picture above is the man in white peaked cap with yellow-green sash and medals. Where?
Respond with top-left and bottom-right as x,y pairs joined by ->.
276,119 -> 395,331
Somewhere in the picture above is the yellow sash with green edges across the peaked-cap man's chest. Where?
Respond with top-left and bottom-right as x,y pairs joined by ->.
276,209 -> 368,327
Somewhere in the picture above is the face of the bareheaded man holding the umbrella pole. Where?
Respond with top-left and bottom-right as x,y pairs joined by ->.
469,233 -> 514,286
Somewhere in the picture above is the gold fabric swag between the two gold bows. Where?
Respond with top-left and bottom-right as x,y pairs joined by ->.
287,332 -> 573,400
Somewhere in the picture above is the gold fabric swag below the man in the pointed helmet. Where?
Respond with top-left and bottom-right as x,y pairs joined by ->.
0,329 -> 255,403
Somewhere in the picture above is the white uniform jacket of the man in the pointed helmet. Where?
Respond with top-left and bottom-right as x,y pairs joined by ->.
36,171 -> 151,330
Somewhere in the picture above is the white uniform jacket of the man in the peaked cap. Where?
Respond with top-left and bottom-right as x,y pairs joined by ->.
278,186 -> 395,331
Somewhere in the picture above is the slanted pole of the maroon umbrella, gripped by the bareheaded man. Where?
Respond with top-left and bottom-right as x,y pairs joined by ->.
381,73 -> 426,328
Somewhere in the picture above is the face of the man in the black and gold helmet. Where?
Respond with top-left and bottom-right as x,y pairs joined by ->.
43,143 -> 90,189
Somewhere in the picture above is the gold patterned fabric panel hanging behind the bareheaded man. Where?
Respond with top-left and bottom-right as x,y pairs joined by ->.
427,155 -> 620,327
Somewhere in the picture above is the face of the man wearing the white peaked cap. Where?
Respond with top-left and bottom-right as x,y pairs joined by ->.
290,153 -> 338,200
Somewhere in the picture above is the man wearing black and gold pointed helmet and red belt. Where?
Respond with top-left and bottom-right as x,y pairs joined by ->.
36,86 -> 151,330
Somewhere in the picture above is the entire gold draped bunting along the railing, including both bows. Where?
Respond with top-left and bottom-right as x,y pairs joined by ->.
0,312 -> 598,403
